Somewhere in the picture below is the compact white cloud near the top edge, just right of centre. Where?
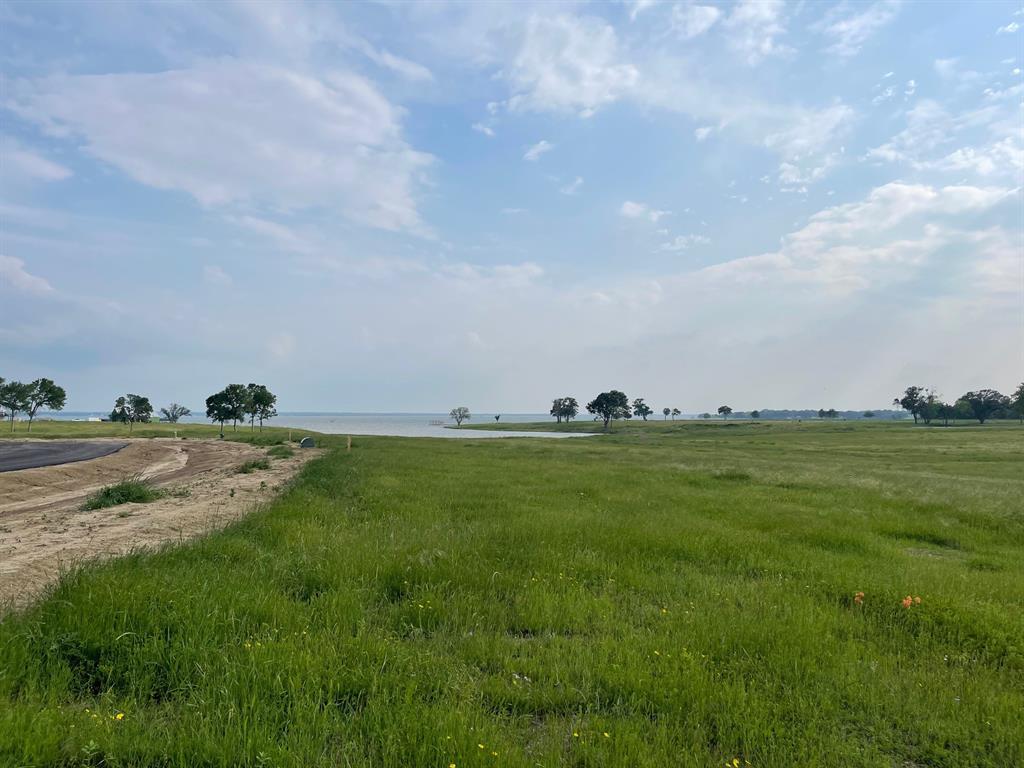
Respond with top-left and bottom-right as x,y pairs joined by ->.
506,15 -> 639,117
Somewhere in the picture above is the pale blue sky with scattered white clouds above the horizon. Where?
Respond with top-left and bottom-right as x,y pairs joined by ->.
0,0 -> 1024,412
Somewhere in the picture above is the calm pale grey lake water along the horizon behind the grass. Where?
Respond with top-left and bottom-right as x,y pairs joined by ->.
40,411 -> 598,439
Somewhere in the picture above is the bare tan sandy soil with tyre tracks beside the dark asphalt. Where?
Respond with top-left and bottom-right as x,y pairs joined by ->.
0,439 -> 323,610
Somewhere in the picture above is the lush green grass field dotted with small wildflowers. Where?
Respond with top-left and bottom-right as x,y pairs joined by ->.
0,422 -> 1024,768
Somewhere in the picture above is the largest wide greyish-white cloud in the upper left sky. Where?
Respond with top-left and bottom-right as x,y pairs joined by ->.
10,59 -> 431,231
